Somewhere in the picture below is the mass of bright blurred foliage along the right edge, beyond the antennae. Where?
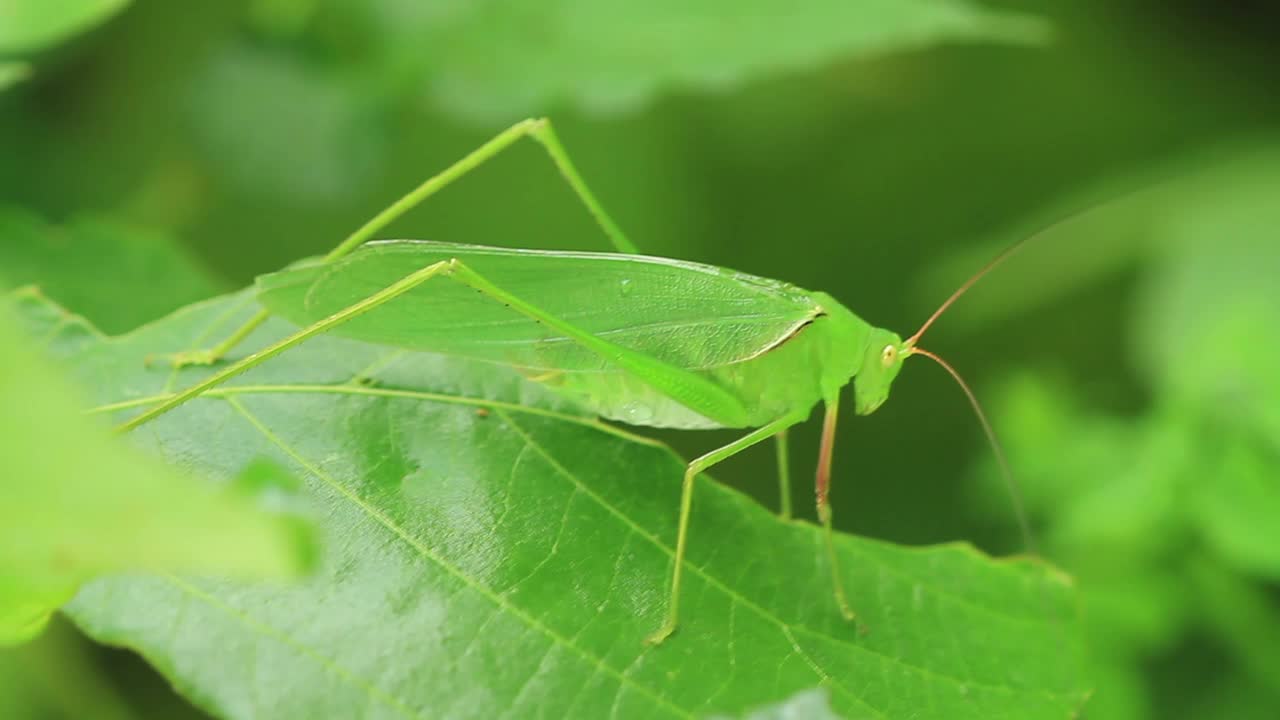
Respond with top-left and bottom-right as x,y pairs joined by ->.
962,143 -> 1280,720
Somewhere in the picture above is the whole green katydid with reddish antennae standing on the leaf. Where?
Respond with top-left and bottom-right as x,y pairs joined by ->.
122,114 -> 1016,643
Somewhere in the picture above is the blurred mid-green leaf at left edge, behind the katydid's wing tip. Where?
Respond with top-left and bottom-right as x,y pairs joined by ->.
0,208 -> 218,332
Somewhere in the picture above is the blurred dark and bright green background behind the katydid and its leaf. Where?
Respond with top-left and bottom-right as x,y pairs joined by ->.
0,0 -> 1280,720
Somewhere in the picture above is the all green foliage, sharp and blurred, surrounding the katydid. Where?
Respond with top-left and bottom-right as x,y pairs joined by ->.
0,0 -> 1280,720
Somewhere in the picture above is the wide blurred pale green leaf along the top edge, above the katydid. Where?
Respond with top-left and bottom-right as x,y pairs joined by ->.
288,0 -> 1046,122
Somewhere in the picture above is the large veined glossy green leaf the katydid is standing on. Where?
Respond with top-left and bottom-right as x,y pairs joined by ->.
12,288 -> 1087,719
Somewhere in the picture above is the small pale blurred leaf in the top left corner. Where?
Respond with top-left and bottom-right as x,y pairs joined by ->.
0,0 -> 129,54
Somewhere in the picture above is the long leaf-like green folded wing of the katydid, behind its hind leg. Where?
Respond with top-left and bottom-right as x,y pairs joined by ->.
257,241 -> 817,373
